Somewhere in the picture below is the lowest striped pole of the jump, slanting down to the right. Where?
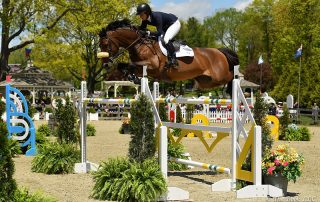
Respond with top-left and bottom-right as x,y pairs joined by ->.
169,157 -> 230,175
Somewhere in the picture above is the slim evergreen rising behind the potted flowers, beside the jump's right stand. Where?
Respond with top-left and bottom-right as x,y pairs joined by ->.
253,94 -> 273,155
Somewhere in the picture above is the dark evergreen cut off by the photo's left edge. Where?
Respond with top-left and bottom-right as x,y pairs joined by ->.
0,120 -> 17,201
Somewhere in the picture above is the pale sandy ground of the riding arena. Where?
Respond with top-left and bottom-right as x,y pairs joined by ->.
14,121 -> 320,202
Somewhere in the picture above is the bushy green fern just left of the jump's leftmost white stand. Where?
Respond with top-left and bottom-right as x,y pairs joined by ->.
31,142 -> 80,174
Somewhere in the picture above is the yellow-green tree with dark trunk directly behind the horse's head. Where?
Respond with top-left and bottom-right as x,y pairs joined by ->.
31,0 -> 141,93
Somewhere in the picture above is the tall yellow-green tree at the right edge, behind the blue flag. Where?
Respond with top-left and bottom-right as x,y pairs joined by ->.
271,0 -> 320,107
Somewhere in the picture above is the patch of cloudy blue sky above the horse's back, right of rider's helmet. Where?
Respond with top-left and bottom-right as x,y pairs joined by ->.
150,0 -> 253,21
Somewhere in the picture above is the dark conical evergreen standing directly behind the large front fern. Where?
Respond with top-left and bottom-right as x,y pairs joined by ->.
129,94 -> 156,162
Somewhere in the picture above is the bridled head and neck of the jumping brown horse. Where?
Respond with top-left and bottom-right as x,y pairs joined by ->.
98,19 -> 139,63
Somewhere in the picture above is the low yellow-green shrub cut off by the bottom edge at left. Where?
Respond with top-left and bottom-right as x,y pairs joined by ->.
13,188 -> 58,202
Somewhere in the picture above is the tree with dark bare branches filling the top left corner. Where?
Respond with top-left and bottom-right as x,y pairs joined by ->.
0,0 -> 78,78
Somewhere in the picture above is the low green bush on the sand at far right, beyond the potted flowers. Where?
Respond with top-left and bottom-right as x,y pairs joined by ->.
283,127 -> 311,141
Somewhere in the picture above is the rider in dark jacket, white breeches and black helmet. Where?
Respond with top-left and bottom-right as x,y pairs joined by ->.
137,3 -> 181,67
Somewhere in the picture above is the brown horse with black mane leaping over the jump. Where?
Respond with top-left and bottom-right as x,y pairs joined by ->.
98,19 -> 239,95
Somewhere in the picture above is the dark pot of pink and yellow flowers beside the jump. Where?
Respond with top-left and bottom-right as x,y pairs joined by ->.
262,144 -> 304,196
